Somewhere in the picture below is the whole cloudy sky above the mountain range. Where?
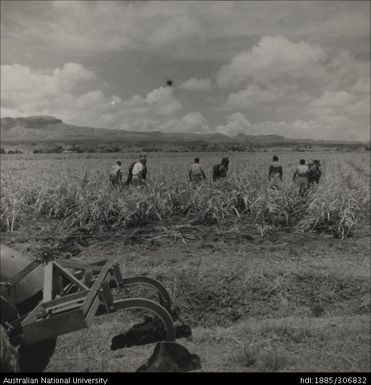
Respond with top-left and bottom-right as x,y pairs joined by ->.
1,0 -> 370,141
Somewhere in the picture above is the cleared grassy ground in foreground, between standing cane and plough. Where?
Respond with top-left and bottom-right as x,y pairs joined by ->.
3,219 -> 370,371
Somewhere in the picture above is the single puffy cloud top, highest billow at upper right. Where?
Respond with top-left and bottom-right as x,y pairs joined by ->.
217,36 -> 327,87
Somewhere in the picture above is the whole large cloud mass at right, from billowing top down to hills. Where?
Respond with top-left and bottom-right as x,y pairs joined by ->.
216,36 -> 370,140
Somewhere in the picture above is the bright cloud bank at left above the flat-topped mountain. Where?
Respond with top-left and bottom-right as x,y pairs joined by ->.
1,63 -> 182,129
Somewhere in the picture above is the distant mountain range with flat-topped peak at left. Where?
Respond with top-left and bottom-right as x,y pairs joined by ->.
1,116 -> 362,146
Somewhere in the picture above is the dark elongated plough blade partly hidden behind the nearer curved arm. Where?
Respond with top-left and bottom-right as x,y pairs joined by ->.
111,317 -> 192,350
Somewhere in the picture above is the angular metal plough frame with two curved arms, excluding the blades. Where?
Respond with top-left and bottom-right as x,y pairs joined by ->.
0,256 -> 175,344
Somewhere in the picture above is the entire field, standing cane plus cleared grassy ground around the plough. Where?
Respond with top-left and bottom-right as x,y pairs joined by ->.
1,149 -> 370,371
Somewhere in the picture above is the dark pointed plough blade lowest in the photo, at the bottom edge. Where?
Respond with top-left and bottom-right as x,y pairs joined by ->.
137,341 -> 201,372
